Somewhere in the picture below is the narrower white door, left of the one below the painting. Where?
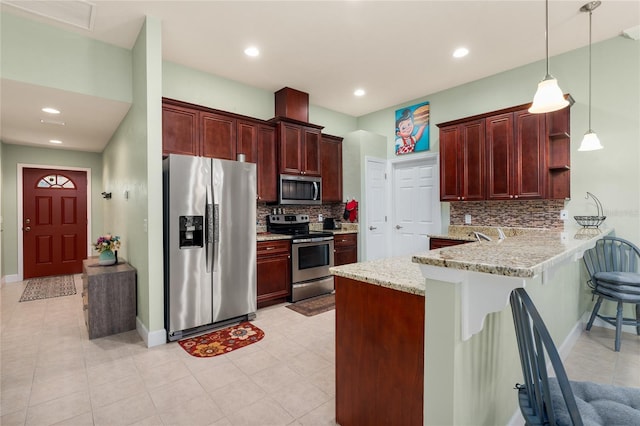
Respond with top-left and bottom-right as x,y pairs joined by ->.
368,158 -> 388,260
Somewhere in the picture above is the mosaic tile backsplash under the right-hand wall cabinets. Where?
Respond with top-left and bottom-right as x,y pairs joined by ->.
449,200 -> 565,229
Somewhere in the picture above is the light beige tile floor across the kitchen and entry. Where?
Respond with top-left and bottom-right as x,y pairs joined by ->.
0,275 -> 640,426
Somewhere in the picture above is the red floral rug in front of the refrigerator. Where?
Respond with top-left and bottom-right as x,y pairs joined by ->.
178,321 -> 264,358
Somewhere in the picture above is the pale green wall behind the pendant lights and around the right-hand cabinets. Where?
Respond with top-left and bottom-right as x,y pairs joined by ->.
358,37 -> 640,245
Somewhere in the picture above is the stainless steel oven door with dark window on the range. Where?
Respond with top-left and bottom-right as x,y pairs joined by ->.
291,237 -> 333,283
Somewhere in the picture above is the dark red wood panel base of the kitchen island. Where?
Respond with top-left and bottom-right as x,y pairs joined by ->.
335,276 -> 425,426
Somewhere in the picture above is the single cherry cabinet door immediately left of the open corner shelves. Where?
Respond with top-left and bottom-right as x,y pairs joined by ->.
512,110 -> 547,199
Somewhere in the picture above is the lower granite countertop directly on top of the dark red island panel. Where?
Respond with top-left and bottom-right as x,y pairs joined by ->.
329,256 -> 425,296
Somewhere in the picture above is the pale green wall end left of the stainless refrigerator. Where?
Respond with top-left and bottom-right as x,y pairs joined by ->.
103,17 -> 164,339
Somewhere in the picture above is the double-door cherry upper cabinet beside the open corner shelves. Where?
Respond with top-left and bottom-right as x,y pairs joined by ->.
485,110 -> 546,200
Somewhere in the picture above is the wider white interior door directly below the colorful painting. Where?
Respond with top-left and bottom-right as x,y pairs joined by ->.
391,156 -> 441,256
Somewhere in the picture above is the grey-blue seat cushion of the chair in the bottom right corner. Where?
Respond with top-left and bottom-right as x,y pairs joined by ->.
549,378 -> 640,426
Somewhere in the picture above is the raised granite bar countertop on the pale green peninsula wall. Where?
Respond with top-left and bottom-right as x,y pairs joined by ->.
412,228 -> 613,278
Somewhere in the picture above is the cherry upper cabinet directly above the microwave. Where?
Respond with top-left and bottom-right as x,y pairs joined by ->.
277,120 -> 322,176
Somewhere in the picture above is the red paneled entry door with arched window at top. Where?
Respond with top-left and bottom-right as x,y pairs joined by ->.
22,168 -> 87,279
